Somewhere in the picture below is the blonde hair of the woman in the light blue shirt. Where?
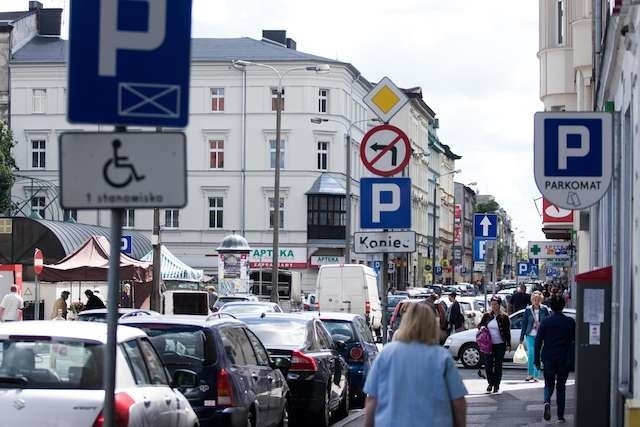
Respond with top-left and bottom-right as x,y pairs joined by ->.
393,303 -> 440,344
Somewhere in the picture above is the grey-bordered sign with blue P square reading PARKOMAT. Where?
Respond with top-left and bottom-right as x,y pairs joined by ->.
534,112 -> 613,210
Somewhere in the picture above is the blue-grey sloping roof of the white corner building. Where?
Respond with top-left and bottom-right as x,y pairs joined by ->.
11,36 -> 340,65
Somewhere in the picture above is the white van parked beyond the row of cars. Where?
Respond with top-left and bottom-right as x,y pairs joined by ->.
316,264 -> 382,334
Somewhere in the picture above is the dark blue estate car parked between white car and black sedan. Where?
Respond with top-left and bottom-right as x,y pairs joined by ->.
122,313 -> 288,427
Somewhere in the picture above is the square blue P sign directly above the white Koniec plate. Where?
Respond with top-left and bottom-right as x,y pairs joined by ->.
360,177 -> 411,229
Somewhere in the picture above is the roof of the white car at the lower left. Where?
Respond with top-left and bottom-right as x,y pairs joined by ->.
0,320 -> 146,344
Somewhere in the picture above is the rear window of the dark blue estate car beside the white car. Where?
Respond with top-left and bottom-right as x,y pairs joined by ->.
136,323 -> 206,367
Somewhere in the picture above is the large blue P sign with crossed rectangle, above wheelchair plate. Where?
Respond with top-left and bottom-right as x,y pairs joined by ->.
68,0 -> 191,127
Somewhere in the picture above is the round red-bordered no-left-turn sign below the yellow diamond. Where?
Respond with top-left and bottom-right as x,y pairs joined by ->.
360,125 -> 411,176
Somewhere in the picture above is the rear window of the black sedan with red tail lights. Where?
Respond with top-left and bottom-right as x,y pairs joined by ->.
242,319 -> 307,348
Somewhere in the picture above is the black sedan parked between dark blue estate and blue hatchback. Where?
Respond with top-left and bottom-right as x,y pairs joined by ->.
241,313 -> 349,427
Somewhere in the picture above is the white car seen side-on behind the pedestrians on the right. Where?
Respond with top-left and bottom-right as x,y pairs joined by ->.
444,308 -> 576,369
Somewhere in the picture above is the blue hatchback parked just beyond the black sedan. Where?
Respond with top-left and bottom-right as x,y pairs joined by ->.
304,312 -> 378,406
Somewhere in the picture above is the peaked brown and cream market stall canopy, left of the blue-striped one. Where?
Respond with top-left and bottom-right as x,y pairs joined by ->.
39,236 -> 152,283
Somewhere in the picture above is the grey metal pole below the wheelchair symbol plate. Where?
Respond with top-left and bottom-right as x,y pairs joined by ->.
103,209 -> 124,426
